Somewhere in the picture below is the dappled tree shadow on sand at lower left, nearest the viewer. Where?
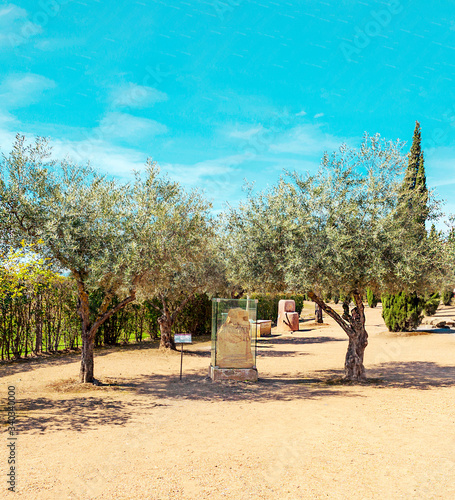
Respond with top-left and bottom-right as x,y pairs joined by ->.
16,393 -> 167,434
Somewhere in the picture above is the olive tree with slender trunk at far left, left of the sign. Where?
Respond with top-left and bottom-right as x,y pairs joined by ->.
0,136 -> 221,382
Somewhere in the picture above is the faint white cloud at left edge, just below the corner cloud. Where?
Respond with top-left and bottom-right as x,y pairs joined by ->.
0,73 -> 56,109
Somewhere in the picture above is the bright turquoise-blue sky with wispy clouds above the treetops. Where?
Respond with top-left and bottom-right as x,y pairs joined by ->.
0,0 -> 455,223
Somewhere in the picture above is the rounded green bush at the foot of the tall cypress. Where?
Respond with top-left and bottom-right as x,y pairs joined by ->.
382,292 -> 426,332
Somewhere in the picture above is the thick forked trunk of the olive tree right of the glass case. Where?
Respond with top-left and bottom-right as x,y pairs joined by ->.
308,291 -> 368,381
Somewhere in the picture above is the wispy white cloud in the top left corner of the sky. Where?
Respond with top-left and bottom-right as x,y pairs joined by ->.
0,3 -> 42,47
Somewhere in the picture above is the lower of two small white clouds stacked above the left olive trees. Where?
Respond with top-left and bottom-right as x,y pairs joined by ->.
97,112 -> 167,141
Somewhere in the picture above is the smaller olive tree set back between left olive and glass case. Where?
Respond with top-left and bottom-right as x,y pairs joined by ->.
137,189 -> 227,349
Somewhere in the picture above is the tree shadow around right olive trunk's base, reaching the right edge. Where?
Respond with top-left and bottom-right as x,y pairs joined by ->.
315,361 -> 455,390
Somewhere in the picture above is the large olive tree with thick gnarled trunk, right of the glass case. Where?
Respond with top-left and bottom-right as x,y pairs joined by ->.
227,135 -> 442,380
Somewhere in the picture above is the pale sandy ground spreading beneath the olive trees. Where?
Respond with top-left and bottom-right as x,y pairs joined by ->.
0,302 -> 455,500
